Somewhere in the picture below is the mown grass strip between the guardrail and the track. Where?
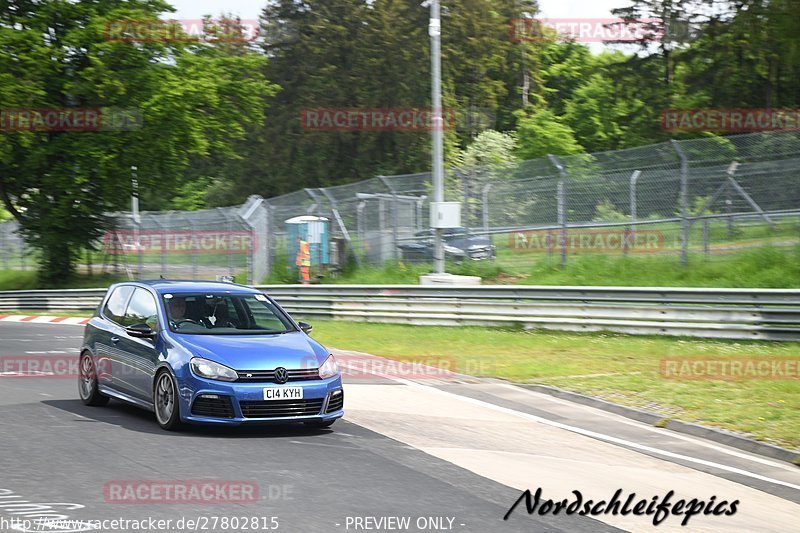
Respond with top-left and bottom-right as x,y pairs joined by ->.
314,321 -> 800,448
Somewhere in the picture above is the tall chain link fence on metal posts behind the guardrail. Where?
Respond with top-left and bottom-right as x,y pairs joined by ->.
0,132 -> 800,283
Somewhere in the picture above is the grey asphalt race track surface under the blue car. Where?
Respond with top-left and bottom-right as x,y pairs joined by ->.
0,323 -> 800,532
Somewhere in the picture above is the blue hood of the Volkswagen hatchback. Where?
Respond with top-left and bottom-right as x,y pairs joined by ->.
172,331 -> 329,370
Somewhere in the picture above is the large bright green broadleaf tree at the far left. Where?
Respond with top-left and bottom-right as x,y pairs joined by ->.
0,0 -> 271,280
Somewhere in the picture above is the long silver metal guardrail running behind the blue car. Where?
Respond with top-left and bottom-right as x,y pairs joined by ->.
0,285 -> 800,341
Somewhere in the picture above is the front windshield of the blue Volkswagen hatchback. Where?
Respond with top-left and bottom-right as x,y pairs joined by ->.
163,293 -> 297,335
